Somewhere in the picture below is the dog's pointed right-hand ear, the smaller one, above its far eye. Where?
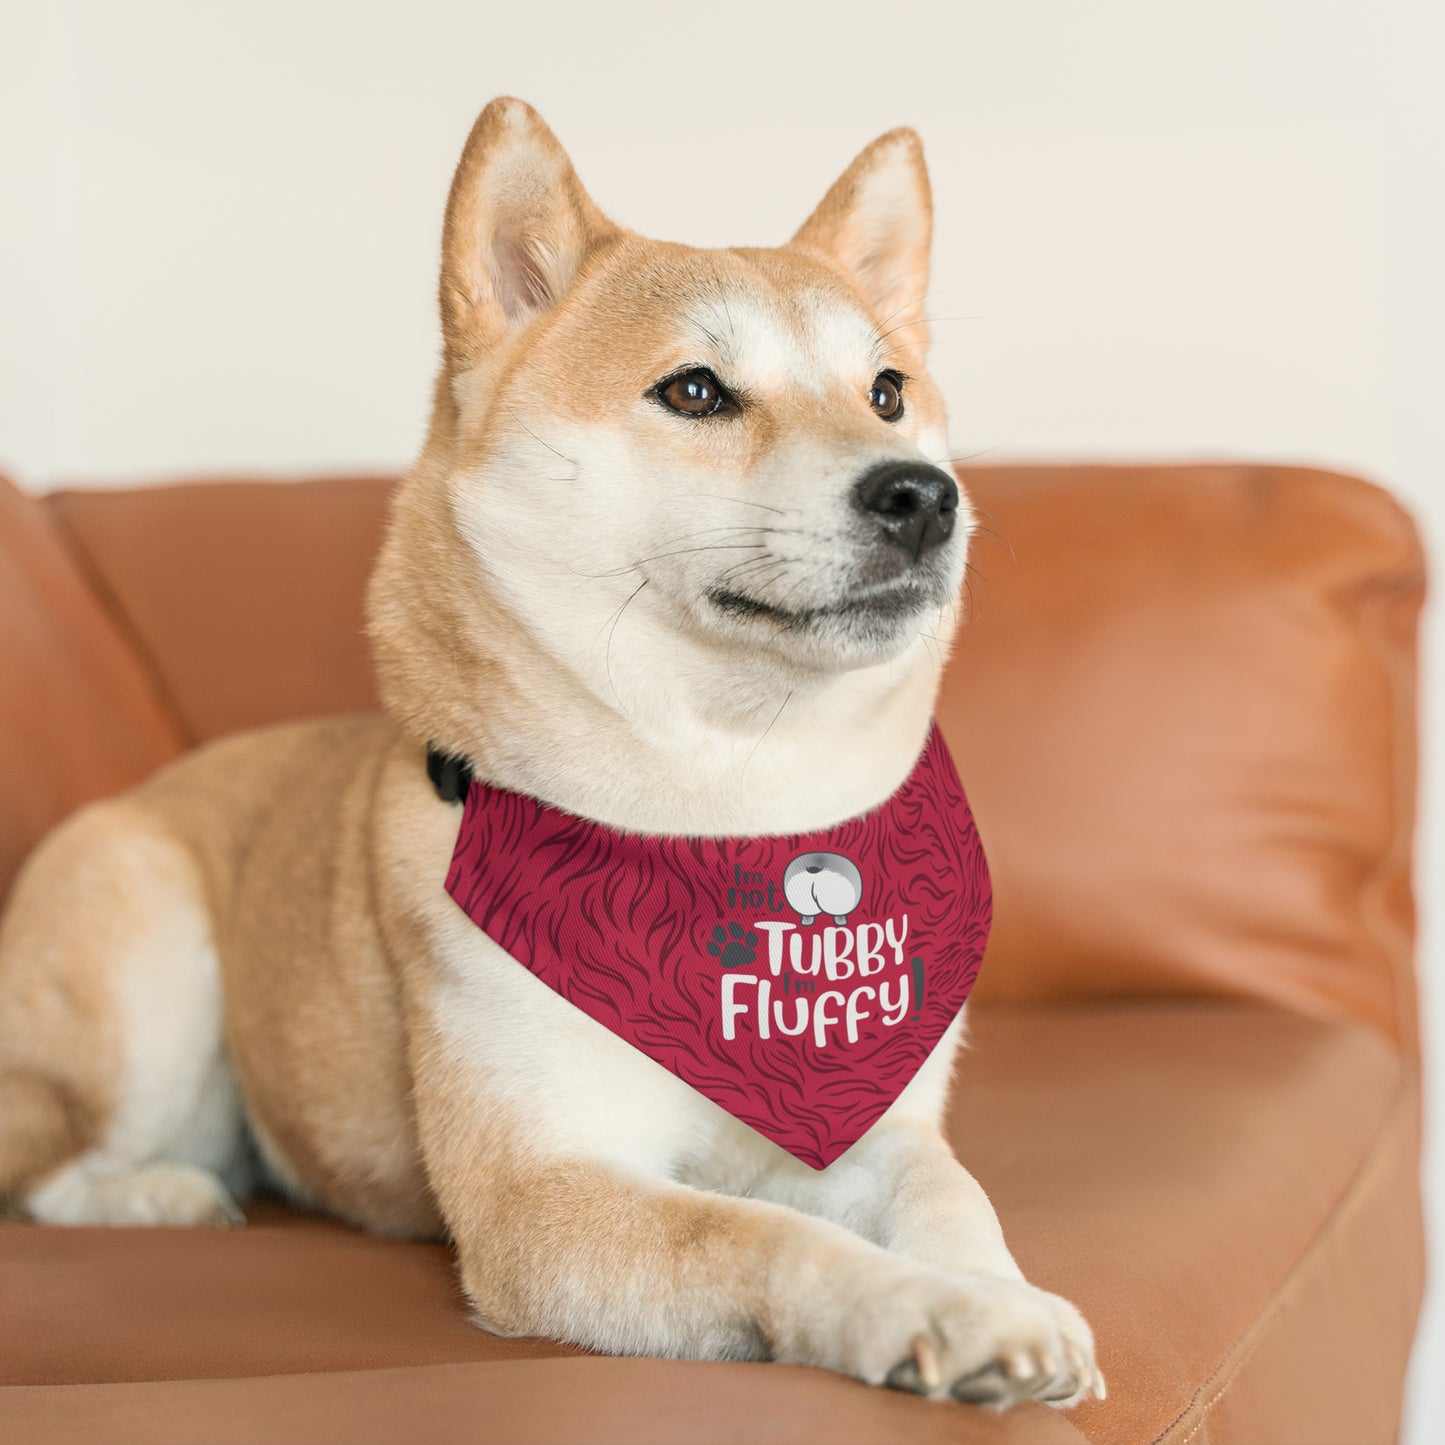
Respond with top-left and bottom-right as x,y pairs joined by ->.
792,127 -> 933,351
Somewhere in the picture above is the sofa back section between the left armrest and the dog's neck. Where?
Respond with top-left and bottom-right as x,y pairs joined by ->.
46,477 -> 393,743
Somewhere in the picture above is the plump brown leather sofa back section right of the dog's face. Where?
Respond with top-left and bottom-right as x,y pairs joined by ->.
939,467 -> 1425,1055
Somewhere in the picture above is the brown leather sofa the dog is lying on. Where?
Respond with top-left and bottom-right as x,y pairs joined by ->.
0,467 -> 1423,1445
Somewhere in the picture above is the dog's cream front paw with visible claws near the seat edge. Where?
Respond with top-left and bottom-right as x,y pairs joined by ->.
842,1269 -> 1104,1409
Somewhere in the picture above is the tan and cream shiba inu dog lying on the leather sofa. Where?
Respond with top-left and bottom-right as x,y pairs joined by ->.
0,100 -> 1104,1405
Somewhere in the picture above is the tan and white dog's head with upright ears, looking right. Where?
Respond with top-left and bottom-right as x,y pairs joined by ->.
371,100 -> 971,774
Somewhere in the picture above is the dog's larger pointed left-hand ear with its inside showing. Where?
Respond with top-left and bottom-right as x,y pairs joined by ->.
441,97 -> 617,366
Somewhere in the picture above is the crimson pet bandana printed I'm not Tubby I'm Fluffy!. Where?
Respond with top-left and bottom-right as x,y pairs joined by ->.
434,724 -> 993,1169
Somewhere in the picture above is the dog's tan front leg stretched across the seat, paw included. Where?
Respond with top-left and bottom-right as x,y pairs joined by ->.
418,1053 -> 1098,1400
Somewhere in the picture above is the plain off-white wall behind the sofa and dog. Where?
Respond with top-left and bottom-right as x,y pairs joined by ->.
0,0 -> 1445,1442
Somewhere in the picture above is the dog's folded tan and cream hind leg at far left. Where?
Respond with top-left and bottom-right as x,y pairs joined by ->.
0,801 -> 246,1224
